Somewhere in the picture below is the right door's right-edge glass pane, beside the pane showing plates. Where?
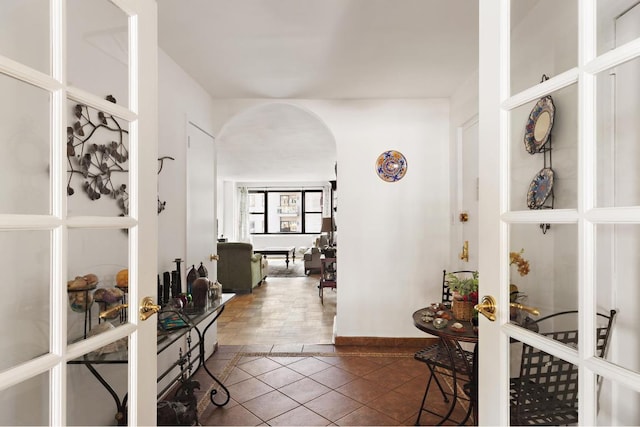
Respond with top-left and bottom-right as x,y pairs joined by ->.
596,56 -> 640,207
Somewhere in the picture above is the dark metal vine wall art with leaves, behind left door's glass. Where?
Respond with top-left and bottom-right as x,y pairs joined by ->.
67,95 -> 129,216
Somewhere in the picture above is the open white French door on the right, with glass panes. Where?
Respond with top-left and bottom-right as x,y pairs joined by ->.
479,0 -> 640,425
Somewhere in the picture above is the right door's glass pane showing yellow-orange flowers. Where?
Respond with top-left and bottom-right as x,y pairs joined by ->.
510,224 -> 578,330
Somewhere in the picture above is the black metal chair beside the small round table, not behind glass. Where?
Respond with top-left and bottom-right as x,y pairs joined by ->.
413,270 -> 476,425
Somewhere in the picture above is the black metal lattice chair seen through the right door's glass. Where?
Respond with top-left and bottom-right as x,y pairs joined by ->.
510,310 -> 616,425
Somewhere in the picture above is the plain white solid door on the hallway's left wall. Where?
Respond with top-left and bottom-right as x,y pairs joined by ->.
187,122 -> 217,280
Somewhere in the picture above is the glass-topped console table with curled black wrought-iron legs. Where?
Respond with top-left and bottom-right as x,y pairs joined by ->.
68,293 -> 235,425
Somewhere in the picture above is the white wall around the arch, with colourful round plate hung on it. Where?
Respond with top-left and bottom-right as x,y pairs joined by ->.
210,99 -> 450,337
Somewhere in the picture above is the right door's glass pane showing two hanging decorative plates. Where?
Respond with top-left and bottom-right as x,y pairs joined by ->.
510,84 -> 578,210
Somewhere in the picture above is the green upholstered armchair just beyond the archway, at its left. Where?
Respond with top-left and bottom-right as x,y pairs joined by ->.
218,242 -> 266,293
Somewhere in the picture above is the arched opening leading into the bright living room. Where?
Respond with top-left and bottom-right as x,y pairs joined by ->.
216,102 -> 337,344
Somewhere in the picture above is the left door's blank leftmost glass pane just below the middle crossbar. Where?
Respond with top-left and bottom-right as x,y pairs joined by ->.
0,231 -> 51,374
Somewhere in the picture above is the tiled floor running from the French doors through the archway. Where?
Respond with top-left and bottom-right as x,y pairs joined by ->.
197,266 -> 472,426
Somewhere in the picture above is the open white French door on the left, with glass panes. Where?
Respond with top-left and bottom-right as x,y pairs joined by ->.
0,0 -> 157,425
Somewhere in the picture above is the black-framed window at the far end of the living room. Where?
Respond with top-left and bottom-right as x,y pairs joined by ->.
249,189 -> 323,234
